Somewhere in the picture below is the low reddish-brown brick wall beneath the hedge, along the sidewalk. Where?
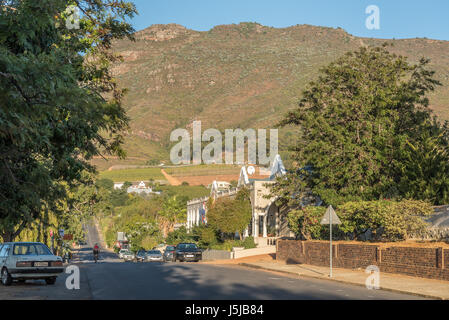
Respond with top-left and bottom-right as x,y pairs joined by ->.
276,240 -> 449,281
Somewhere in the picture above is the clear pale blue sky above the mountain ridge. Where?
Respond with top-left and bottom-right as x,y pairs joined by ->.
129,0 -> 449,40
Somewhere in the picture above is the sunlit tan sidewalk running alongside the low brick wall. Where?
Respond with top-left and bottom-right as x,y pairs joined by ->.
236,256 -> 449,300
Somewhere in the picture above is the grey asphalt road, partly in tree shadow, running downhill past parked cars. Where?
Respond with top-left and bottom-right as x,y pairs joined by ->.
0,224 -> 426,300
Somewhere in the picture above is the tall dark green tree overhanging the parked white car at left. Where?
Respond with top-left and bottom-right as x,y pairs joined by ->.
0,0 -> 136,241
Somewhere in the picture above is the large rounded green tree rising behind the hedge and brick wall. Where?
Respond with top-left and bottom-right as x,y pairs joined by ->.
273,47 -> 449,206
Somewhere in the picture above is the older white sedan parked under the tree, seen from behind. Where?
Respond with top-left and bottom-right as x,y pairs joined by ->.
0,242 -> 64,286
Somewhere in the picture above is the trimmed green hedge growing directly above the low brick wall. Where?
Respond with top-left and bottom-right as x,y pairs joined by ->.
287,200 -> 433,241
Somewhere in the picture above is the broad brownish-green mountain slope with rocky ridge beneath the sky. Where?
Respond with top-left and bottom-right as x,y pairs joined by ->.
90,23 -> 449,168
